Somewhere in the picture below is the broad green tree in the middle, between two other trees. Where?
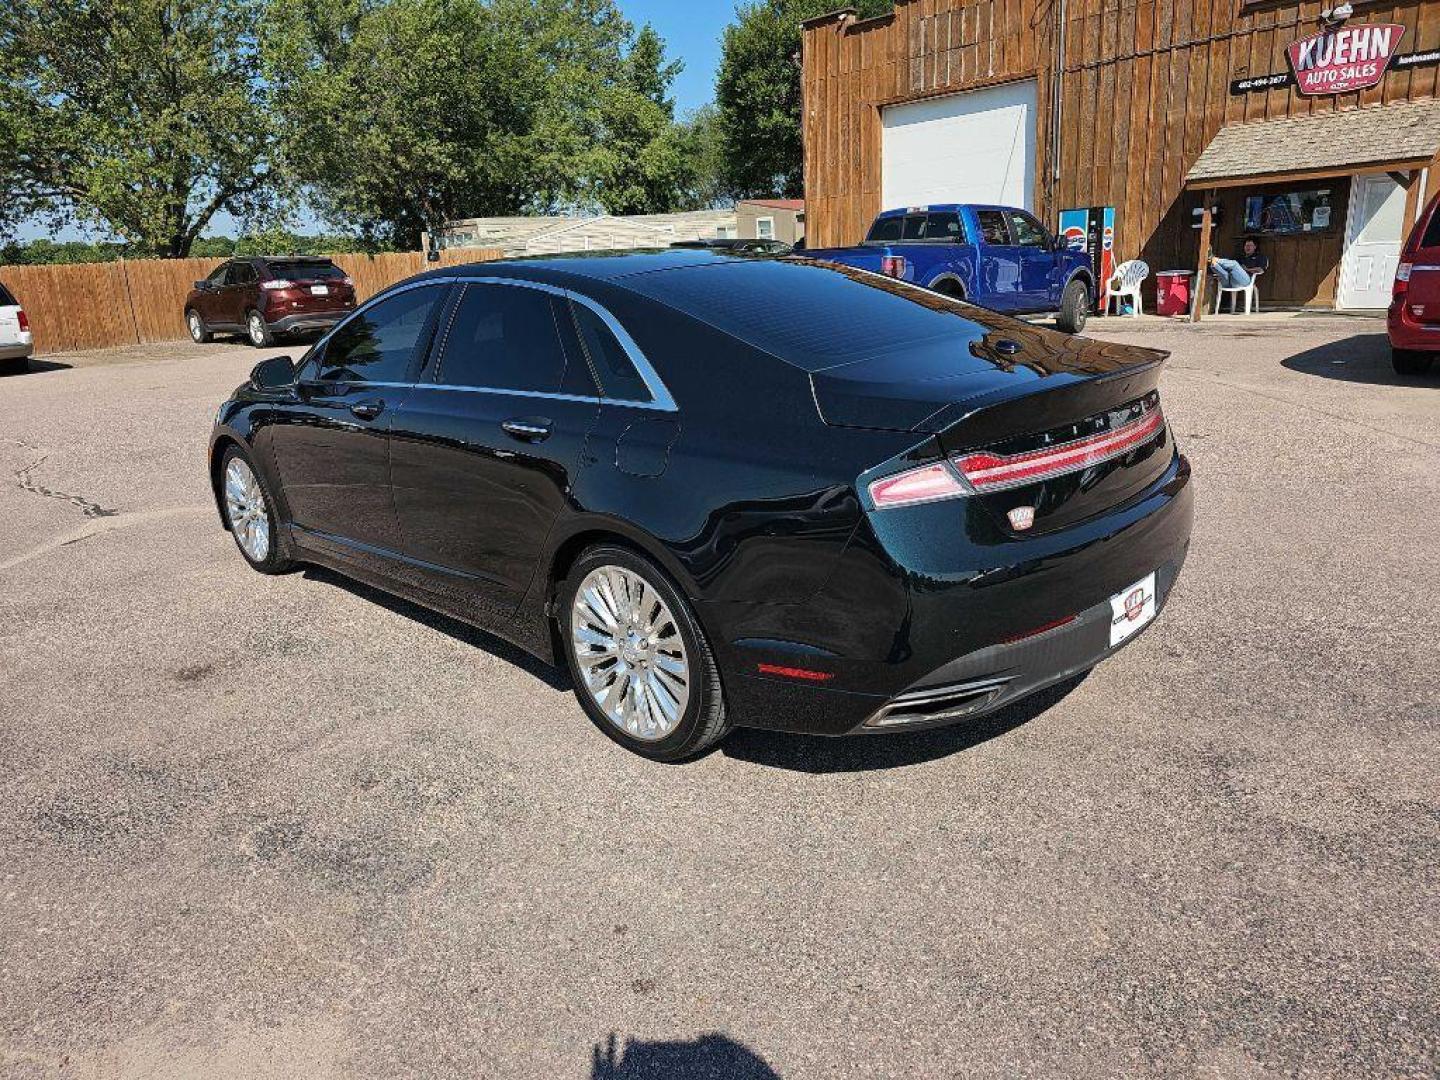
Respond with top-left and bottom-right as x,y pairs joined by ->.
264,0 -> 702,248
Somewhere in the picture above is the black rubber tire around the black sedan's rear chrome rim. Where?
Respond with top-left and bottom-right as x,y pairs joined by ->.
557,544 -> 732,762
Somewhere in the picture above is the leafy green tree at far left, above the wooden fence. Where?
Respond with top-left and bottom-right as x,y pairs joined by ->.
0,0 -> 276,256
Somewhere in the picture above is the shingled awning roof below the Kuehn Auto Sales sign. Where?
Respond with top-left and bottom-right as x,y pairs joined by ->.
1185,98 -> 1440,187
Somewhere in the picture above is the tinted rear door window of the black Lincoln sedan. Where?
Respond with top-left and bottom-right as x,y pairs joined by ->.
435,285 -> 564,393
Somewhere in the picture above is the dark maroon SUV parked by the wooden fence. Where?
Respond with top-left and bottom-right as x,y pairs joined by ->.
184,255 -> 356,348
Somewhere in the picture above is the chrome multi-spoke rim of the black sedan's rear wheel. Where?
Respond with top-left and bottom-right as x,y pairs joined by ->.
570,566 -> 690,742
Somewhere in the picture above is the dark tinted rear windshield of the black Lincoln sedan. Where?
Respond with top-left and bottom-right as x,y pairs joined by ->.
624,258 -> 985,372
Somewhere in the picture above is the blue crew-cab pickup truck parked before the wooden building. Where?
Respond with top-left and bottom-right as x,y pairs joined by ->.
805,203 -> 1096,334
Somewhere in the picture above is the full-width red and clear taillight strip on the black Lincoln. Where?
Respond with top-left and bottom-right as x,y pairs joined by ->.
868,405 -> 1165,510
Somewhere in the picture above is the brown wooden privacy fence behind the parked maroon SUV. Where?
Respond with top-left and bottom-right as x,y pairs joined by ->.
0,248 -> 501,354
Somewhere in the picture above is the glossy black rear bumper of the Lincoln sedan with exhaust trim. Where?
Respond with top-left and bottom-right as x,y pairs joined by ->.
703,455 -> 1194,734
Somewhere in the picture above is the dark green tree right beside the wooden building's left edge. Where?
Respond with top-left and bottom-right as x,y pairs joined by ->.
716,0 -> 891,199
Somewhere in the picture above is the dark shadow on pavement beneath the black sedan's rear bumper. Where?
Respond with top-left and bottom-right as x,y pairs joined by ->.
720,671 -> 1090,773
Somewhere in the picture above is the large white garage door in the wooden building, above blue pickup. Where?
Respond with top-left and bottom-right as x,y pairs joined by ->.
880,81 -> 1035,210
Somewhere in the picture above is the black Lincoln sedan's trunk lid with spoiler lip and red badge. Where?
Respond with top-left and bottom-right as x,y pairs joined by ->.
811,325 -> 1174,534
